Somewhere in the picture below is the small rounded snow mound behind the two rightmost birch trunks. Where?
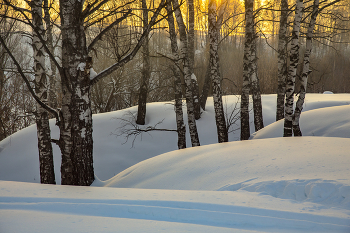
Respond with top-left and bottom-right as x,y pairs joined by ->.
252,105 -> 350,139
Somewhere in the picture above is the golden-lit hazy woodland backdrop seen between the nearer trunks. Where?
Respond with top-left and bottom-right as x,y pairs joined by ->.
0,0 -> 350,140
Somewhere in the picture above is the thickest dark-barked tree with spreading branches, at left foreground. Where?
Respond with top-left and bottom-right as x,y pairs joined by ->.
0,0 -> 165,186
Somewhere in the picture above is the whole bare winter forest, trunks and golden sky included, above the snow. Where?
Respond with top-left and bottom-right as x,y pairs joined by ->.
0,0 -> 350,185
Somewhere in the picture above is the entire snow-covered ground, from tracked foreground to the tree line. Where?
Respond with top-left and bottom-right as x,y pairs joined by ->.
0,94 -> 350,233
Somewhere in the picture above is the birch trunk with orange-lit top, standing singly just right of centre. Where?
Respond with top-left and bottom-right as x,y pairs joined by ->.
208,0 -> 228,143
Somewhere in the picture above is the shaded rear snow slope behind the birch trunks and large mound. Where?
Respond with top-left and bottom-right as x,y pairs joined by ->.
0,94 -> 350,183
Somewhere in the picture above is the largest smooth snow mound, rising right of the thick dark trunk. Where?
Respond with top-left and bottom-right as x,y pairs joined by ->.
96,137 -> 350,210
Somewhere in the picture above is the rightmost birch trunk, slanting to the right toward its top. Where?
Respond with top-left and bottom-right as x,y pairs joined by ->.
293,0 -> 320,136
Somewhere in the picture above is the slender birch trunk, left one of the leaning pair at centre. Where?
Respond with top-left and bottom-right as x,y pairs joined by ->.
167,0 -> 186,149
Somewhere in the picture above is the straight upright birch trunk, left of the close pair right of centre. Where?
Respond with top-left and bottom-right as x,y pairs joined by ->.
241,0 -> 254,140
